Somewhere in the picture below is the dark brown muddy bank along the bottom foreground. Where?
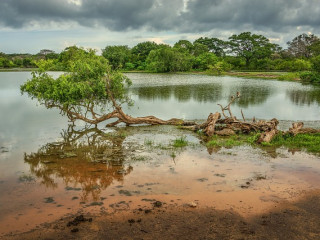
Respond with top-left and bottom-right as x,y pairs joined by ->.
4,191 -> 320,240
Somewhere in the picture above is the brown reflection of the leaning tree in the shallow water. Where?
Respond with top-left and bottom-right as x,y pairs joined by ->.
24,125 -> 133,201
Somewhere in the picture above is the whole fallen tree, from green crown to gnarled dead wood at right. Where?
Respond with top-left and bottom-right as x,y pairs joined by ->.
21,47 -> 319,143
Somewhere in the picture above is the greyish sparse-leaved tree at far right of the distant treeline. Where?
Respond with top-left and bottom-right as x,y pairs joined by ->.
287,33 -> 320,58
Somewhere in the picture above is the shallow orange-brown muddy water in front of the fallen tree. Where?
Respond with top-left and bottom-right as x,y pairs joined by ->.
0,126 -> 320,234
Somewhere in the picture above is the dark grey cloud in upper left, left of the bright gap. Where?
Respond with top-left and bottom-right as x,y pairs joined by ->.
0,0 -> 183,31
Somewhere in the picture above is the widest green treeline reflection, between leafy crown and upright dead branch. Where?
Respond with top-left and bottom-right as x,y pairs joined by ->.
131,83 -> 222,102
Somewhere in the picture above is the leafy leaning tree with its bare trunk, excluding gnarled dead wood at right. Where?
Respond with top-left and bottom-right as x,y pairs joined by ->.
21,47 -> 190,126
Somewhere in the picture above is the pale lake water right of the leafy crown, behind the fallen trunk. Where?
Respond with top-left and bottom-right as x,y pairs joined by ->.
124,74 -> 320,121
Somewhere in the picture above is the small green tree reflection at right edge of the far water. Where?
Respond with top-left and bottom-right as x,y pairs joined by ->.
286,88 -> 320,106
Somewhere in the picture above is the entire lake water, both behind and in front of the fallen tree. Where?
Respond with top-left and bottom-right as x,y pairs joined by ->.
0,72 -> 320,236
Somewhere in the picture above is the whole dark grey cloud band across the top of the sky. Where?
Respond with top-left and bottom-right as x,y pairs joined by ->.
0,0 -> 320,33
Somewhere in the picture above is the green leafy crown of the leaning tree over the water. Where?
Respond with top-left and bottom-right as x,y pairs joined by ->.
21,48 -> 130,107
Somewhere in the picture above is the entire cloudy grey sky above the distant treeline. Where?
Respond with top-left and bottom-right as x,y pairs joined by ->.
0,0 -> 320,53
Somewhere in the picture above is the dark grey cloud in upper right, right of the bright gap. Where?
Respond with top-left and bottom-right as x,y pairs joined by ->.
182,0 -> 320,32
